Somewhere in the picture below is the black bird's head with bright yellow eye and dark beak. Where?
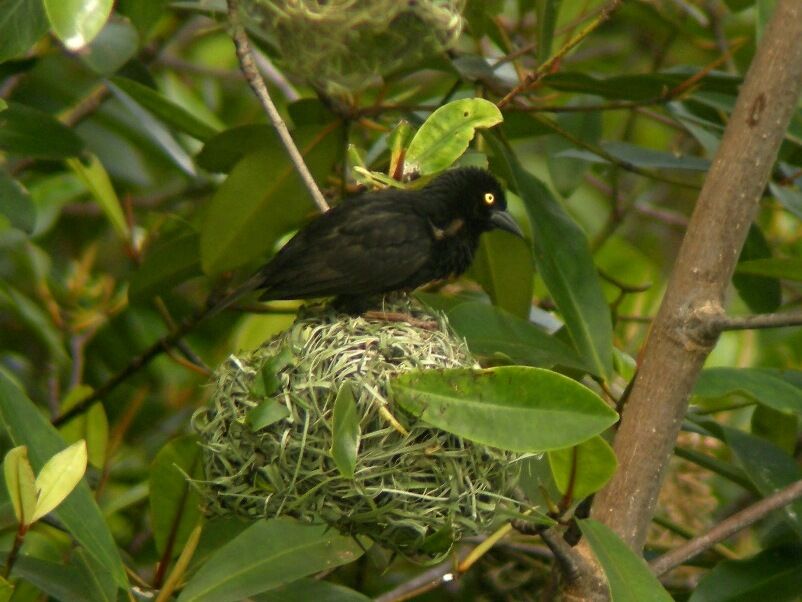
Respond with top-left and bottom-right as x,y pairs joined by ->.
427,167 -> 524,238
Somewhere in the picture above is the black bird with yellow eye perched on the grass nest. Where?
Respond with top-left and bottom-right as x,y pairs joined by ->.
216,167 -> 523,309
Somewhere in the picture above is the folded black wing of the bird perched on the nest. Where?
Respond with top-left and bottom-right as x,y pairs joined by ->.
260,199 -> 432,299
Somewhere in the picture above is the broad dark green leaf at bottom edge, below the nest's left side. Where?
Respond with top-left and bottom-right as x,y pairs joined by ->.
178,519 -> 363,602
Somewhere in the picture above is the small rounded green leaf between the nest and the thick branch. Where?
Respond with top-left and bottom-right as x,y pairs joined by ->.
549,436 -> 618,500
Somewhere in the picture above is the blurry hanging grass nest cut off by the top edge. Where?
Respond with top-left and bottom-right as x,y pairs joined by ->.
243,0 -> 465,96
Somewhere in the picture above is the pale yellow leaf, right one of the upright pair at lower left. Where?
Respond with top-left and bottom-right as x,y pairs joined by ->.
31,439 -> 88,522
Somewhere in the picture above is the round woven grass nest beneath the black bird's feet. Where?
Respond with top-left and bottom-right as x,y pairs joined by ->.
193,301 -> 520,561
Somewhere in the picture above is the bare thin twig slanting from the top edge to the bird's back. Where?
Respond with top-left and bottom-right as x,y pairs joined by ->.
227,0 -> 329,212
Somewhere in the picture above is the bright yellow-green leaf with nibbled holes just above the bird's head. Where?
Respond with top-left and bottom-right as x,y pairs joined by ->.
404,98 -> 504,176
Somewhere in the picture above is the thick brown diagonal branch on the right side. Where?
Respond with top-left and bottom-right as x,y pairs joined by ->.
593,0 -> 802,550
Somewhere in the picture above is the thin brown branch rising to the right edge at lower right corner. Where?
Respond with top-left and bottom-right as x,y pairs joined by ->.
649,479 -> 802,575
